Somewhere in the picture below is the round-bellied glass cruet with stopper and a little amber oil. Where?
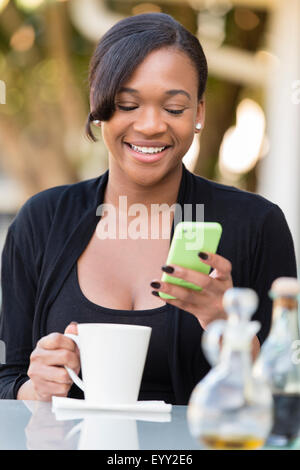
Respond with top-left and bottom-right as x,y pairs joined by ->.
187,287 -> 272,450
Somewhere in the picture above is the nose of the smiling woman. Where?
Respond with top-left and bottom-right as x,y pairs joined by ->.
133,107 -> 167,136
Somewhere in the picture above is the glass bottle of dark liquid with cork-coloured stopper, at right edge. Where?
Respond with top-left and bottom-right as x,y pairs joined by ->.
255,277 -> 300,447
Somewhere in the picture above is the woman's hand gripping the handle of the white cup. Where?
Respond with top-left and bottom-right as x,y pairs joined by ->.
17,324 -> 80,401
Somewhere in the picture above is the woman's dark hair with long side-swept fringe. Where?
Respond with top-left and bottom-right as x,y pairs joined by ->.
86,13 -> 207,142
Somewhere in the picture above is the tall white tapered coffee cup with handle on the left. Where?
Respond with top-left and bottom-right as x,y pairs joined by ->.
65,323 -> 152,405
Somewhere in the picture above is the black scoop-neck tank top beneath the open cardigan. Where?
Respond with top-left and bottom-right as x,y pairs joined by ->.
46,263 -> 174,403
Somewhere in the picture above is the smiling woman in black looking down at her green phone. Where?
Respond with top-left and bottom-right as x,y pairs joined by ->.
0,13 -> 296,404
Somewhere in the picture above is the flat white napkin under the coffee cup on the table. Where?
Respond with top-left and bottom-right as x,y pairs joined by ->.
52,397 -> 172,413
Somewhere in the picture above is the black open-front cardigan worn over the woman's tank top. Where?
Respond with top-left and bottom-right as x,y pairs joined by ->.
0,165 -> 297,405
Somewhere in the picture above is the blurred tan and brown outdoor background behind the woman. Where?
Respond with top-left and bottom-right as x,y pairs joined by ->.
0,0 -> 300,259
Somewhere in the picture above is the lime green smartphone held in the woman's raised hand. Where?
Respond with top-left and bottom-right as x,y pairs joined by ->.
159,222 -> 222,299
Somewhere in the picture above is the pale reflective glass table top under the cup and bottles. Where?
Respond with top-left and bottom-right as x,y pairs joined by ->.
0,400 -> 300,450
